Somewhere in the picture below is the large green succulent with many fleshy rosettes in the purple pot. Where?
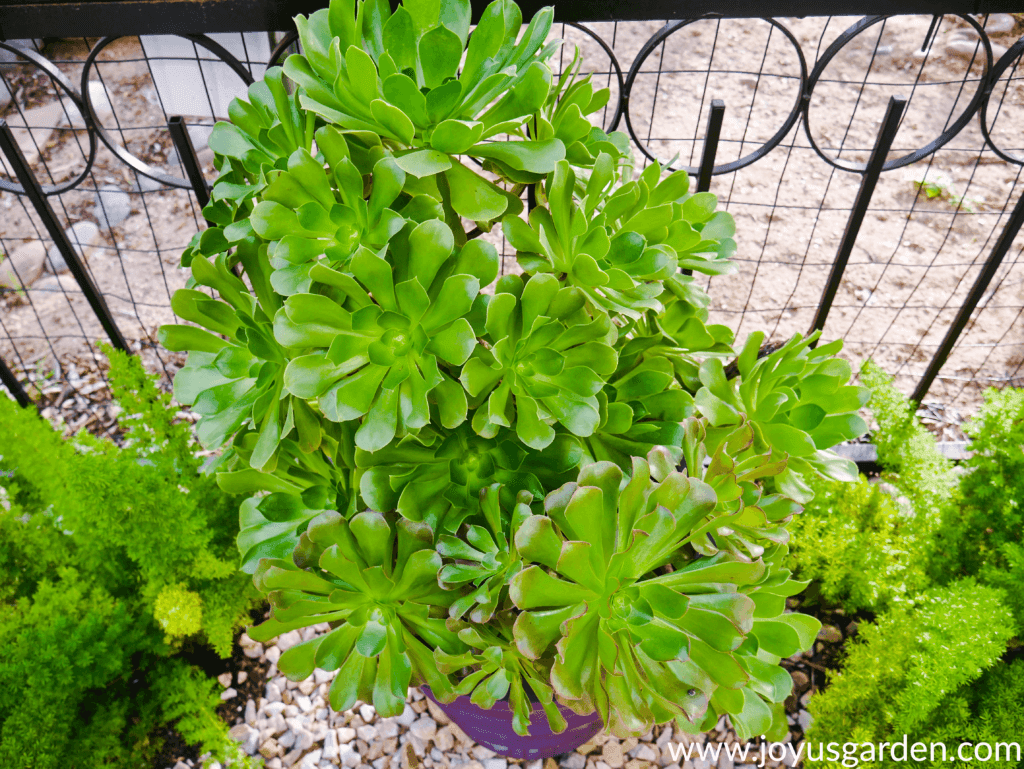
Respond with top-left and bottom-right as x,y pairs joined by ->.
161,0 -> 866,734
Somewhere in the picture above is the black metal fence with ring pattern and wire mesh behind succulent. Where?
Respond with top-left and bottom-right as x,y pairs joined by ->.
0,0 -> 1024,438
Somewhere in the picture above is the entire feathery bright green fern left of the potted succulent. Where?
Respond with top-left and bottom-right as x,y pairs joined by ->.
0,350 -> 258,769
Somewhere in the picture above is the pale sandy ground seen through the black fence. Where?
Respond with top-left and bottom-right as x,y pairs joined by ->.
0,16 -> 1024,430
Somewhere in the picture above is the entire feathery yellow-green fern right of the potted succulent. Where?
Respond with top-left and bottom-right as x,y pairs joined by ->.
793,361 -> 1024,757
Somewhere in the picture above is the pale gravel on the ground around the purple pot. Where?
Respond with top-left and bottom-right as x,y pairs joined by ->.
159,624 -> 823,769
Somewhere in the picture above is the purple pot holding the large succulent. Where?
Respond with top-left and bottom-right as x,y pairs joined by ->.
421,686 -> 604,759
